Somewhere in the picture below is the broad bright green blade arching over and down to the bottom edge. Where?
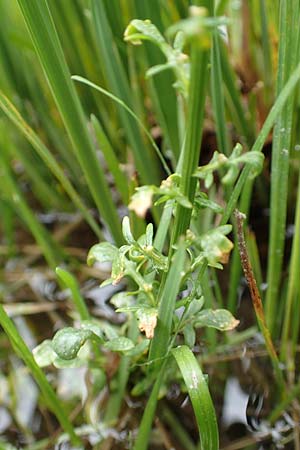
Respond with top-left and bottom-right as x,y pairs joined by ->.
172,345 -> 219,450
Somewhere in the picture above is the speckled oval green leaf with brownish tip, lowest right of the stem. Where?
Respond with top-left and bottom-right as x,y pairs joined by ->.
194,309 -> 240,331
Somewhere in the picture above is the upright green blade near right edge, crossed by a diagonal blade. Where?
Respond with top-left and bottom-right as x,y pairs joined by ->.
266,0 -> 300,333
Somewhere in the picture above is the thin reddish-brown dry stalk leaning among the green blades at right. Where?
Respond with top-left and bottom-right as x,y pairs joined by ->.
234,209 -> 284,389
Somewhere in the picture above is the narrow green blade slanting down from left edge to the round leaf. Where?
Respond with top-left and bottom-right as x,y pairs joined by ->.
0,91 -> 102,239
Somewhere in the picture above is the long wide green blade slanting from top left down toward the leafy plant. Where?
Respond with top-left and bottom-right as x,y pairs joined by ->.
14,0 -> 123,244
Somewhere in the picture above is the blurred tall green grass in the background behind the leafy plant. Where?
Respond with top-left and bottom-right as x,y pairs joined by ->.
0,0 -> 300,449
